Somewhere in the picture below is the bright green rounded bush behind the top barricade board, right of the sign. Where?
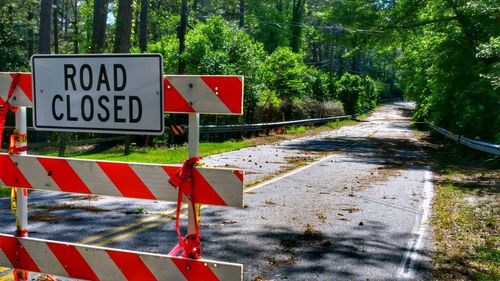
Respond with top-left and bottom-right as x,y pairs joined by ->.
148,17 -> 265,122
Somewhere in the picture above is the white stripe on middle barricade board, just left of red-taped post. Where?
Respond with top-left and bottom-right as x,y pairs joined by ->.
130,165 -> 178,201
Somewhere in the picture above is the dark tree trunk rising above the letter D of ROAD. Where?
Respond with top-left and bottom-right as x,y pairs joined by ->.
113,0 -> 132,53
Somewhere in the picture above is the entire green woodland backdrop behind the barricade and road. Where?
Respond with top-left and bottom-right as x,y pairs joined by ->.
0,0 -> 500,142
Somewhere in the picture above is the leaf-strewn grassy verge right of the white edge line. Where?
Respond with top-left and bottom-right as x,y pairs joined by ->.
430,140 -> 500,280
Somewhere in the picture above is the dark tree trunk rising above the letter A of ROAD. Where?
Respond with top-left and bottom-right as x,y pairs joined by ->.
91,0 -> 108,53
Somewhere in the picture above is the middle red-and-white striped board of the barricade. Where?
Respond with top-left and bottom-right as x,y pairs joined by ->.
0,153 -> 244,207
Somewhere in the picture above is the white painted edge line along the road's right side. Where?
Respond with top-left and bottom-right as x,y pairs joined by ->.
397,167 -> 434,281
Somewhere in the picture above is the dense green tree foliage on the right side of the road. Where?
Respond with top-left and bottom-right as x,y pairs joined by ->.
400,1 -> 500,142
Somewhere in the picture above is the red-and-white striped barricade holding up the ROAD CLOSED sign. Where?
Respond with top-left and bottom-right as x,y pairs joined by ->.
0,66 -> 244,280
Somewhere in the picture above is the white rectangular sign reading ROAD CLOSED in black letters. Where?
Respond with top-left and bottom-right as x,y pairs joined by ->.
32,54 -> 163,135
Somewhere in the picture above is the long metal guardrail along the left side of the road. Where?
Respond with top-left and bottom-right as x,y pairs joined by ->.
200,115 -> 353,134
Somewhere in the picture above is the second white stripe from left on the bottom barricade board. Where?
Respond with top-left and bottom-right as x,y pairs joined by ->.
76,246 -> 127,281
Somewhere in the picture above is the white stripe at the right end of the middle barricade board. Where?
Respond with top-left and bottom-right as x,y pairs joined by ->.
197,168 -> 243,207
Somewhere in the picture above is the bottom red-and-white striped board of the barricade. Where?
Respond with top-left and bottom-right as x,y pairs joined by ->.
0,234 -> 243,281
